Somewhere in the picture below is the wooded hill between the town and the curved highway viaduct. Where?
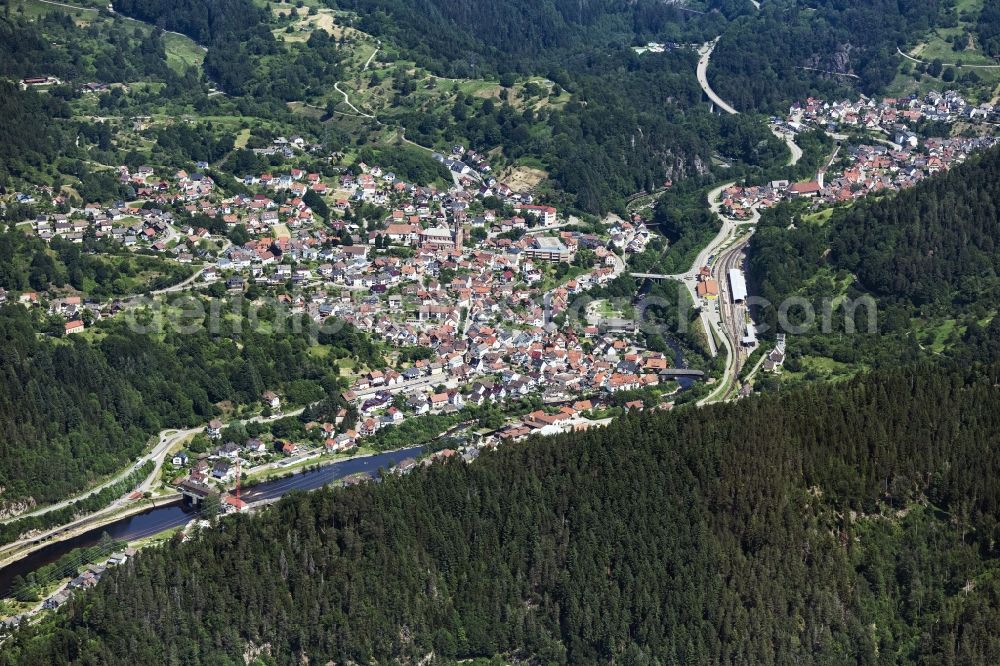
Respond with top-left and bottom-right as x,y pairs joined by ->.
386,47 -> 787,213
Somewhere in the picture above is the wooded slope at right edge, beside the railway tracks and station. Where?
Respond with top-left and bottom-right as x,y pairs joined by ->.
748,149 -> 1000,382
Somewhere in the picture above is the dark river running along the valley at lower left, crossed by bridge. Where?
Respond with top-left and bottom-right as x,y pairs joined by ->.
0,446 -> 422,597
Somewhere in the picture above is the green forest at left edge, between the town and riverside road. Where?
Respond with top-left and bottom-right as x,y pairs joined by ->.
0,305 -> 378,510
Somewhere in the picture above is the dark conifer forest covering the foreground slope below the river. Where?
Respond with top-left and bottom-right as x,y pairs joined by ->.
0,364 -> 1000,665
